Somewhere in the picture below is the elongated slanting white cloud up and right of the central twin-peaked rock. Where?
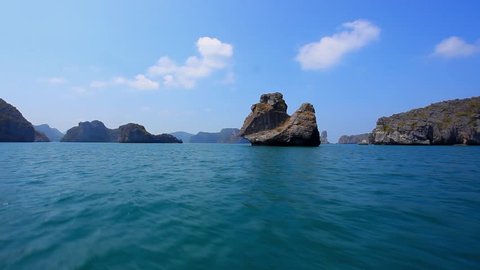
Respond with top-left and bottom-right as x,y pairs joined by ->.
295,20 -> 380,70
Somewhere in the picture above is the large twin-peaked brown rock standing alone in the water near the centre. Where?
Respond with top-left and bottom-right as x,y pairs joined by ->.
240,93 -> 320,146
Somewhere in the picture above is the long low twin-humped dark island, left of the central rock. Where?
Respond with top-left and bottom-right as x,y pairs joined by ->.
62,120 -> 182,143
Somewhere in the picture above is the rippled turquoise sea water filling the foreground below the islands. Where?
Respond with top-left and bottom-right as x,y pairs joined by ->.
0,143 -> 480,269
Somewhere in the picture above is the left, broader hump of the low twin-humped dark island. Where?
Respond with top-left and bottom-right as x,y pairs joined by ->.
62,120 -> 118,142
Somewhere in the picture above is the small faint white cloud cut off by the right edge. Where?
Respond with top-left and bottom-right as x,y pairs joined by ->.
433,36 -> 480,58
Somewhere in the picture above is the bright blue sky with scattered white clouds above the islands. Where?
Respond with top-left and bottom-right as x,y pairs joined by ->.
0,0 -> 480,142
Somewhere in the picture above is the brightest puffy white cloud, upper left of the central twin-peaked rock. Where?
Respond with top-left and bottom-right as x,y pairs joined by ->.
148,37 -> 233,88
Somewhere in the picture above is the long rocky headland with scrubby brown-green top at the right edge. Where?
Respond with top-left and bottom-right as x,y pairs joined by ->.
370,97 -> 480,145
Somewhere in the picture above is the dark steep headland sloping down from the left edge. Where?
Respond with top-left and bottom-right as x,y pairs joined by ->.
0,98 -> 35,142
